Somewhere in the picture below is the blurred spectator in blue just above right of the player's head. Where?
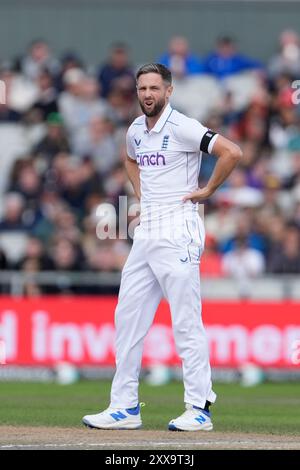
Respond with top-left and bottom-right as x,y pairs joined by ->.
158,36 -> 203,79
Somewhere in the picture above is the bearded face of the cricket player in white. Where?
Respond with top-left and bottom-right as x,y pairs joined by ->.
137,73 -> 173,117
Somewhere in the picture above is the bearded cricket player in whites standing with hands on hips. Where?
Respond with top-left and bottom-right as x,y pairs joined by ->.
83,64 -> 241,431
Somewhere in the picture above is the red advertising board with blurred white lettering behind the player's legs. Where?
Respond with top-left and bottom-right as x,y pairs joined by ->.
0,297 -> 300,368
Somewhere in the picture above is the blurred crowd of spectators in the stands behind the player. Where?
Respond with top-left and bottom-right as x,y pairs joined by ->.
0,30 -> 300,295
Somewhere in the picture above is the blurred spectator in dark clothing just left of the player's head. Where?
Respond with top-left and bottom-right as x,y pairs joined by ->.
98,43 -> 135,98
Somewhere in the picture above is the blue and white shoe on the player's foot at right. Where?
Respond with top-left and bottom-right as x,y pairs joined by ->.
169,403 -> 213,431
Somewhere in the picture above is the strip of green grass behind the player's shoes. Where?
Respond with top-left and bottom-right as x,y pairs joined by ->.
0,381 -> 300,435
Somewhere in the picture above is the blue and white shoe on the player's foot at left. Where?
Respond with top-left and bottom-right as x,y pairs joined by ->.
82,405 -> 142,429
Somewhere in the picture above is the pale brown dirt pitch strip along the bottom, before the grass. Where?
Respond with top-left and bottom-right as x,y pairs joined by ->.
0,426 -> 300,450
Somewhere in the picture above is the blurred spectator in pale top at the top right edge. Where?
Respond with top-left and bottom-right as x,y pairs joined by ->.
268,29 -> 300,79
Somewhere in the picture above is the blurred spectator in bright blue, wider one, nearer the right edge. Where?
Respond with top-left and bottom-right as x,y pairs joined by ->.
204,36 -> 262,80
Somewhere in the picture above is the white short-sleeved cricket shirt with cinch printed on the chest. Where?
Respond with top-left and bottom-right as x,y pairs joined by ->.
126,104 -> 217,225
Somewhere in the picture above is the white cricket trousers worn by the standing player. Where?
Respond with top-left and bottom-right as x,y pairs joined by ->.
110,213 -> 216,408
